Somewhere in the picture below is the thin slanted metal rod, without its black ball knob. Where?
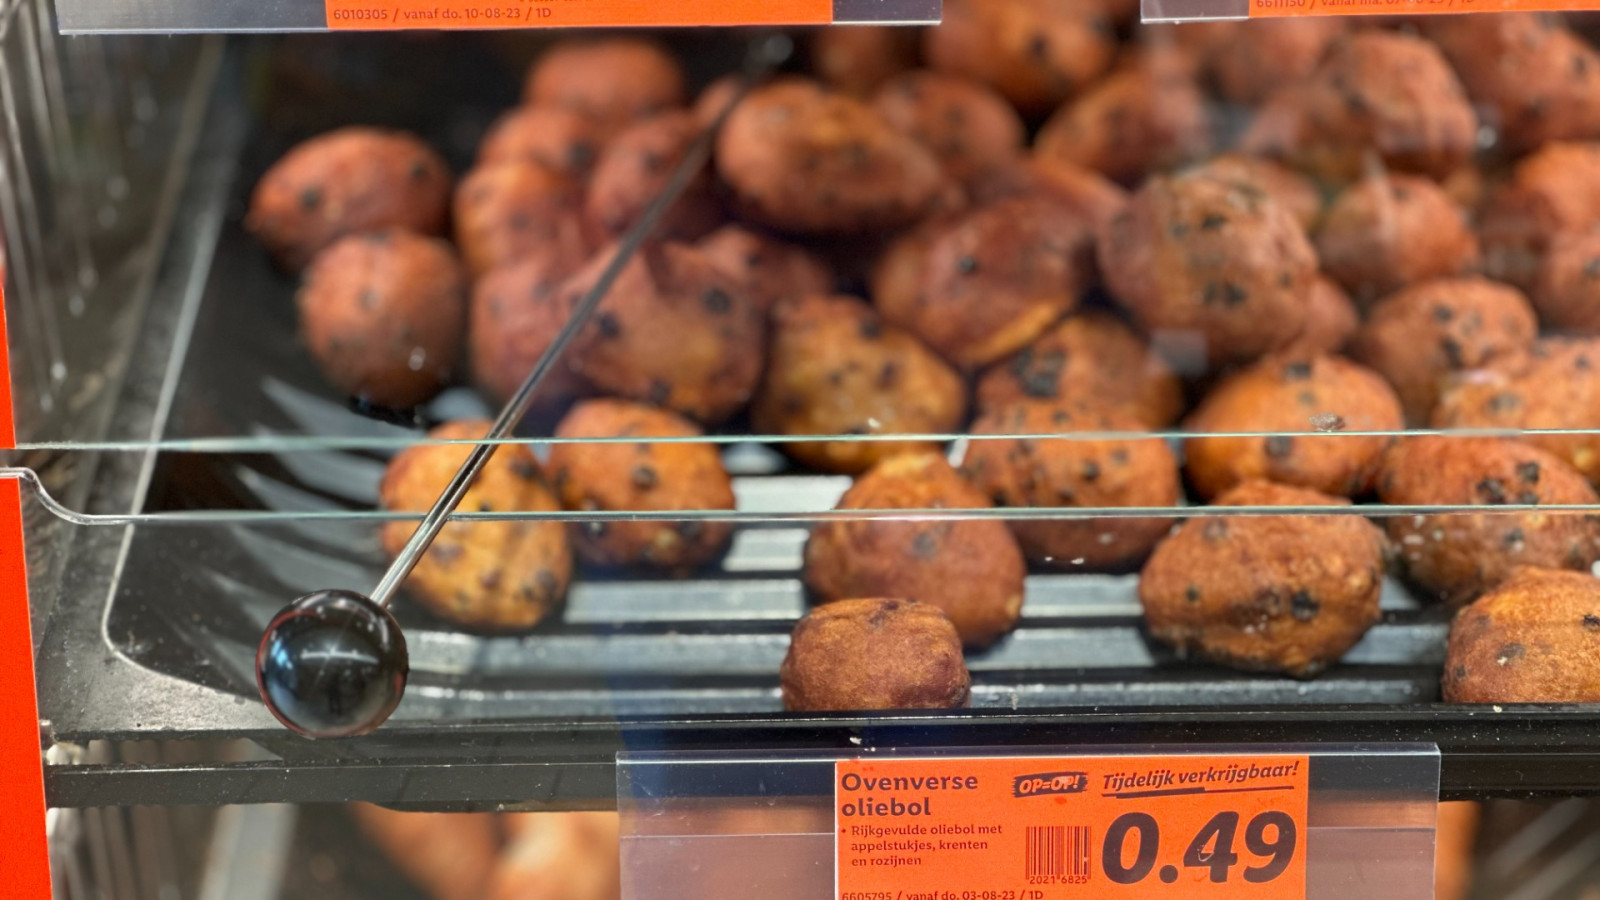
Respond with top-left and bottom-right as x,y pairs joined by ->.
371,37 -> 792,605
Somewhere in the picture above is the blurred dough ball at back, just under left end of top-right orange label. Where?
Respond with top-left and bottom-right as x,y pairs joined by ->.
1186,16 -> 1349,104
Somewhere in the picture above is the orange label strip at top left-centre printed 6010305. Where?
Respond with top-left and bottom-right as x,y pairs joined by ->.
325,0 -> 834,30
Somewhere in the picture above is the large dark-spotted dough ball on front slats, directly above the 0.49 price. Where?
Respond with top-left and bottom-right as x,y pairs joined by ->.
1139,480 -> 1384,677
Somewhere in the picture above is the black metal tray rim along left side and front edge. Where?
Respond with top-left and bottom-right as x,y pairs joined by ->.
9,5 -> 1600,809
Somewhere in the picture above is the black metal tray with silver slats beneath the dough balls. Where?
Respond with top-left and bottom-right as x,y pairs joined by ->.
18,21 -> 1600,809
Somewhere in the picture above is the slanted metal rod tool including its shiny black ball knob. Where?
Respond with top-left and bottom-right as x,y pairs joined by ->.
256,35 -> 794,738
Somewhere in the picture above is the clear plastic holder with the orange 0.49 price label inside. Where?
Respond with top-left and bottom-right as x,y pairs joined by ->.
618,745 -> 1438,900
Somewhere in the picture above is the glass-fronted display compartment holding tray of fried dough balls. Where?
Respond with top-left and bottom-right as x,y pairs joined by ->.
9,0 -> 1600,895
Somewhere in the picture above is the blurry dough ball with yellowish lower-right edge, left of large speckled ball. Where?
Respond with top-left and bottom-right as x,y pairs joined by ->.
872,197 -> 1090,370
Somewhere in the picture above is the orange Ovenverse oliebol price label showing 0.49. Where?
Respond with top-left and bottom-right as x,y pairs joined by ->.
834,754 -> 1310,900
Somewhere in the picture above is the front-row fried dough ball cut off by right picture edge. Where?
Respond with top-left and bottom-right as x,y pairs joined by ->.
1442,569 -> 1600,703
